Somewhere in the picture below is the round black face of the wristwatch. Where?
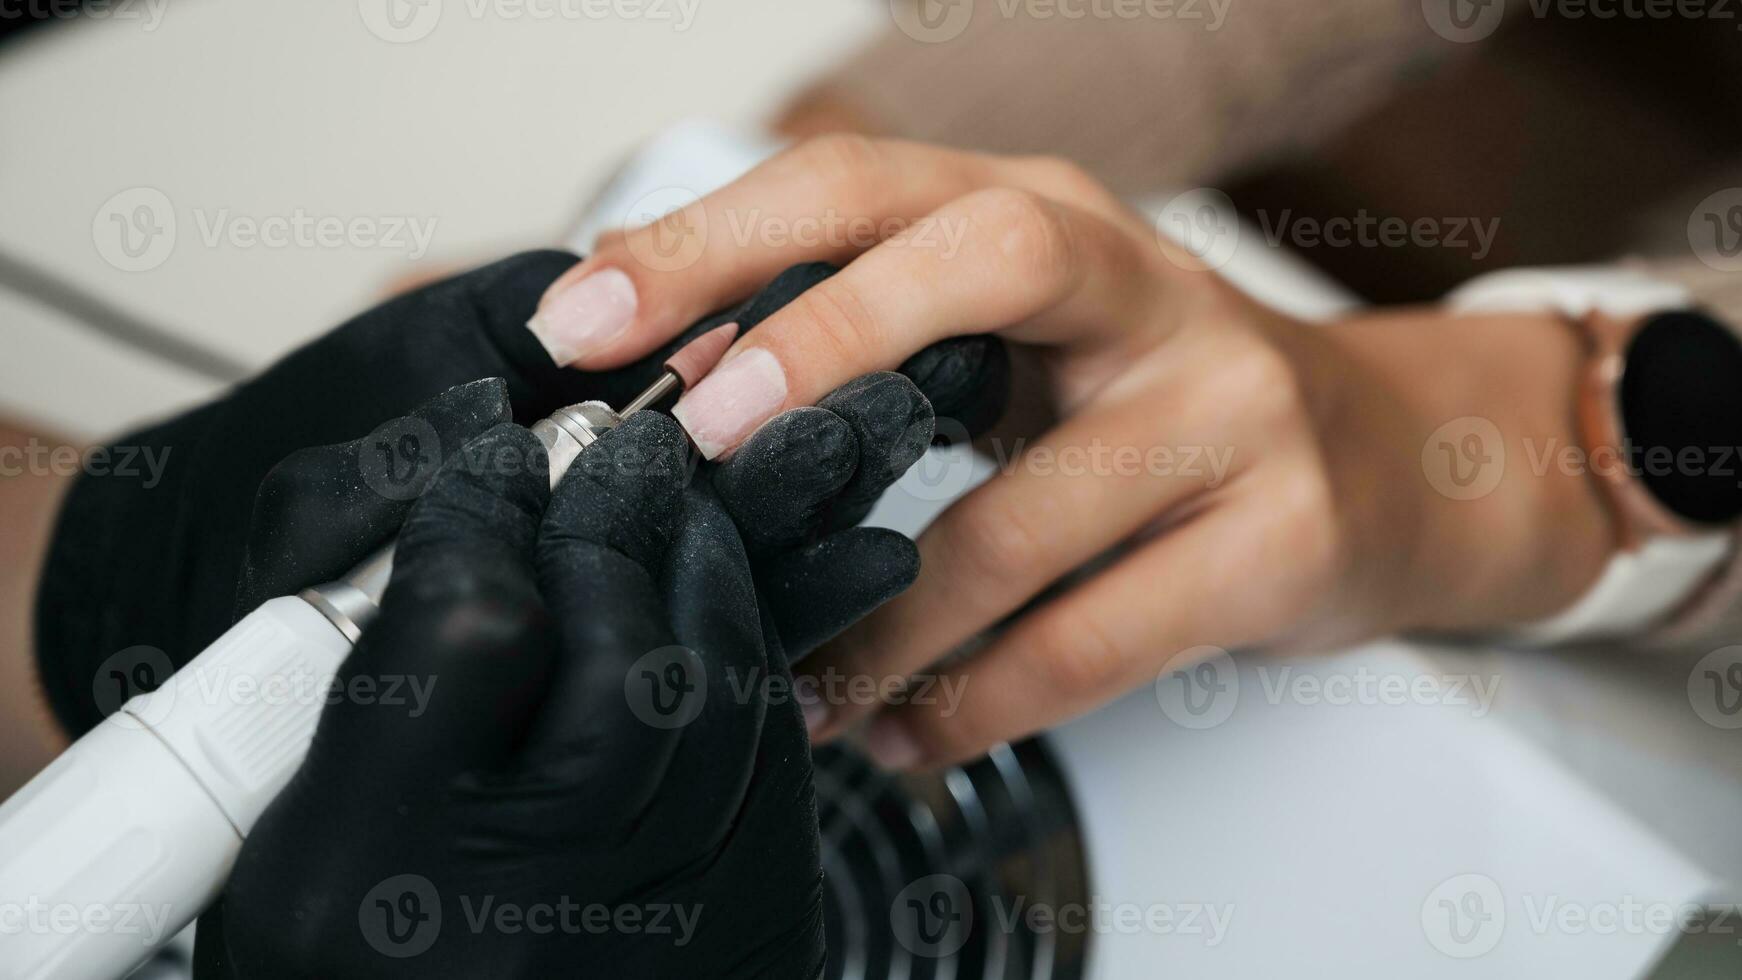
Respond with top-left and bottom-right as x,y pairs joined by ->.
1620,312 -> 1742,526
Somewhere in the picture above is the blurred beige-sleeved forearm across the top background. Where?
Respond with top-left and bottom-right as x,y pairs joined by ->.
784,0 -> 1467,191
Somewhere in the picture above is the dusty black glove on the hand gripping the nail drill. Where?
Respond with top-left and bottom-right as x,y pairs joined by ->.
199,413 -> 824,980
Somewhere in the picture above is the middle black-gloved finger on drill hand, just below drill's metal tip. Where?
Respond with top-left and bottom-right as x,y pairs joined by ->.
521,413 -> 695,823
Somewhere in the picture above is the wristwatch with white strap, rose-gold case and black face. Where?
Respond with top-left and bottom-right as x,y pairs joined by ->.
1448,268 -> 1742,644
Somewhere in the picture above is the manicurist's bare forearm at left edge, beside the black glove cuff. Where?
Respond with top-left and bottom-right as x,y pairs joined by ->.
0,425 -> 71,786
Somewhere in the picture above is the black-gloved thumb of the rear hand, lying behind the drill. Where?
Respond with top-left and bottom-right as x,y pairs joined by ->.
235,378 -> 509,616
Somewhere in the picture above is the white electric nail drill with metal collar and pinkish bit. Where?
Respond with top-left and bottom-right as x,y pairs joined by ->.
0,375 -> 700,980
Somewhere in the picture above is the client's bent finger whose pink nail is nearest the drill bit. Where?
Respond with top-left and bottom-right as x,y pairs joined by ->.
672,195 -> 1165,458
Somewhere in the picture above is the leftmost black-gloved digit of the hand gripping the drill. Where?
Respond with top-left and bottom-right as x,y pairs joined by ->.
305,425 -> 556,799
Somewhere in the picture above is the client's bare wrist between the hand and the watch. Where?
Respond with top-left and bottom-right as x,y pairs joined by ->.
1331,310 -> 1617,630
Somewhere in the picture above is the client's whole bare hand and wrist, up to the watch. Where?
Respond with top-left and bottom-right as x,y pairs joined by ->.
526,136 -> 1615,766
